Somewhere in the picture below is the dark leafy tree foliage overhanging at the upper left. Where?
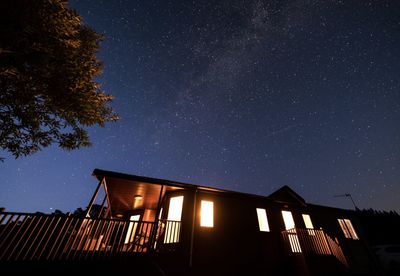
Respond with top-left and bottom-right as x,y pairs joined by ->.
0,0 -> 118,158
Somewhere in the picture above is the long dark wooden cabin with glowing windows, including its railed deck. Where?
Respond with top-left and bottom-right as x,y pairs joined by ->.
0,169 -> 379,275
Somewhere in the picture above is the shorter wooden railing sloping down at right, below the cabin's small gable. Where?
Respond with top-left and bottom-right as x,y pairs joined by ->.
282,228 -> 348,267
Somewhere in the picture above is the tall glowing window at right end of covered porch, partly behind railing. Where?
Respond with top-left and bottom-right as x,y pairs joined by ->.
164,196 -> 183,243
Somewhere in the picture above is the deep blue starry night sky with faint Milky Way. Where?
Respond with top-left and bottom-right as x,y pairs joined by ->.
0,0 -> 400,212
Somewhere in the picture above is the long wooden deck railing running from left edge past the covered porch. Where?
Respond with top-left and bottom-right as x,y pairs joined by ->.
0,212 -> 180,261
